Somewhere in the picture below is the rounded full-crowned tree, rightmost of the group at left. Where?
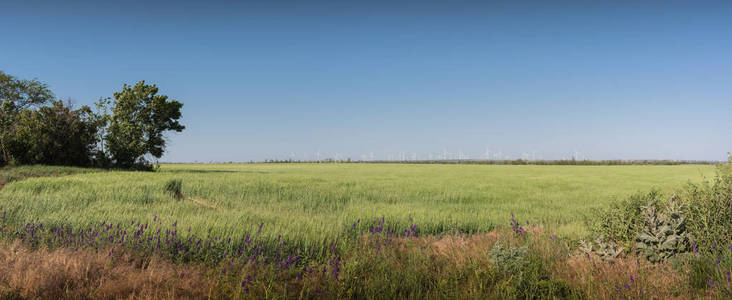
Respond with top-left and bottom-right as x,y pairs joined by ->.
105,80 -> 185,168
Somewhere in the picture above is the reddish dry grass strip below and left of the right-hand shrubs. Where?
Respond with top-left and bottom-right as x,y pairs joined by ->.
421,226 -> 718,299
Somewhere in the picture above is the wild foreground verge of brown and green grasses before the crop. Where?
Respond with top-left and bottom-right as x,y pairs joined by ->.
0,219 -> 732,299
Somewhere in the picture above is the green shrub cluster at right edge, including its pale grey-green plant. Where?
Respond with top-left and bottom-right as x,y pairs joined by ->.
589,164 -> 732,261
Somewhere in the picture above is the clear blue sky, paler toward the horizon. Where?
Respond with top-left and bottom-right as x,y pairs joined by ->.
0,0 -> 732,162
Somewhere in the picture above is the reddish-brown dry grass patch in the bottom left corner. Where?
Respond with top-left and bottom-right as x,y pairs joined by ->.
0,242 -> 214,299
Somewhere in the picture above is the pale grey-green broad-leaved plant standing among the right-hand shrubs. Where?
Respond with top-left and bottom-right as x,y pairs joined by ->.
635,196 -> 689,263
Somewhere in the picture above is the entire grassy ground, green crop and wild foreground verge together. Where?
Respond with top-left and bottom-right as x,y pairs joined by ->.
0,163 -> 732,299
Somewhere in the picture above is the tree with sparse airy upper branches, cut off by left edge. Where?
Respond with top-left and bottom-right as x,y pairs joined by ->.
0,71 -> 54,165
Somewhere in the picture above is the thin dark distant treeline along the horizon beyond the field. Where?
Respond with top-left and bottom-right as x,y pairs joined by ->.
177,159 -> 722,166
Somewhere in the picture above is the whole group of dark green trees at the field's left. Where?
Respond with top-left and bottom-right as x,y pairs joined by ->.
0,71 -> 185,169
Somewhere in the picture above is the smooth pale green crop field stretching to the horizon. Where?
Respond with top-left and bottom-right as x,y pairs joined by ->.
0,164 -> 714,244
